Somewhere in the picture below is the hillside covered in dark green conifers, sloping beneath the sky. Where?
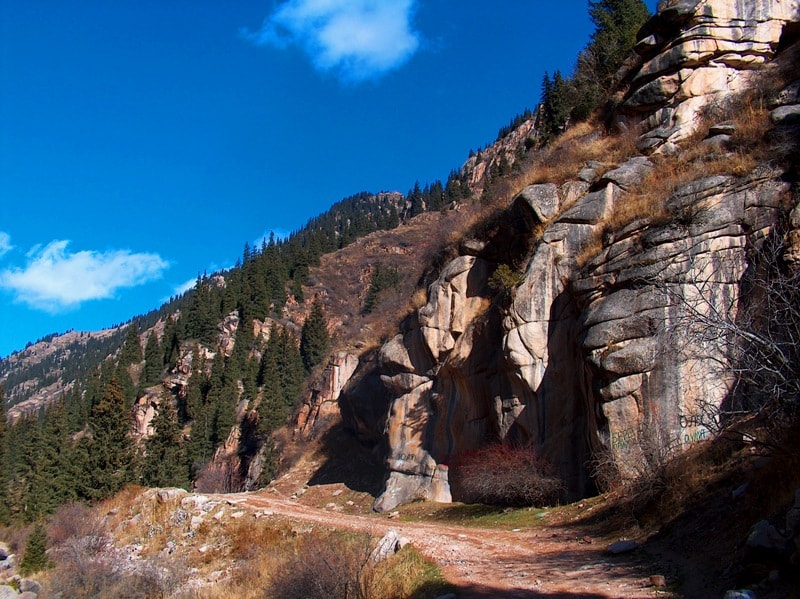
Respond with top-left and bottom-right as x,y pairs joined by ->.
0,0 -> 648,522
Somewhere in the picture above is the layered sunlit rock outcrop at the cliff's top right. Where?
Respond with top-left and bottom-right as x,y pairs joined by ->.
618,0 -> 800,152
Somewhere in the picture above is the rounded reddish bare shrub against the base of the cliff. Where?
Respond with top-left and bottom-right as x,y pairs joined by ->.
450,443 -> 564,506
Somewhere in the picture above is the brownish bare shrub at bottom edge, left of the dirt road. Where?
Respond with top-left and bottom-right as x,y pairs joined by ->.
264,531 -> 375,599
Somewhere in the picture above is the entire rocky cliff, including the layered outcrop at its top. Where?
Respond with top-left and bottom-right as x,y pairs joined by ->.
304,0 -> 800,510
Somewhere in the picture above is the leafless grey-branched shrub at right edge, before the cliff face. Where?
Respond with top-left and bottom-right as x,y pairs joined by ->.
656,231 -> 800,432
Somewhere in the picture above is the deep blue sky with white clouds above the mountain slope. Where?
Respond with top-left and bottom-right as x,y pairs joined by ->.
0,0 -> 655,356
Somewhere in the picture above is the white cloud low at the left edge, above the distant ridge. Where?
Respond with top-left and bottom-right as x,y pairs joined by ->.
0,240 -> 169,312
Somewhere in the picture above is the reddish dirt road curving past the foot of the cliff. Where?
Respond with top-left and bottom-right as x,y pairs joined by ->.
220,494 -> 669,599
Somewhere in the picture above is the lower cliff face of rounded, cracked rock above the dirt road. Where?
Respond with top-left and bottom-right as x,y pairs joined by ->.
366,149 -> 788,510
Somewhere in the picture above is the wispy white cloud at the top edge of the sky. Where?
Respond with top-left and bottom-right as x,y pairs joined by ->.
243,0 -> 420,83
